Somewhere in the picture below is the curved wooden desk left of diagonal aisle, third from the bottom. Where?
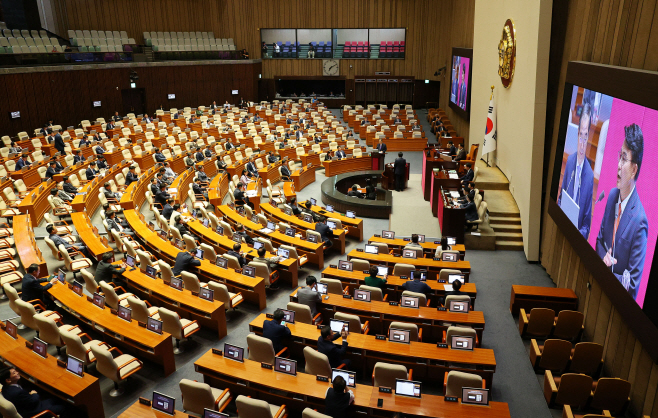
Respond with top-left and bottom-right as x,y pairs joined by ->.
122,268 -> 226,340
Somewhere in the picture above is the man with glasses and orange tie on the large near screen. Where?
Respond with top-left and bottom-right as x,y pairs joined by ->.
596,124 -> 649,299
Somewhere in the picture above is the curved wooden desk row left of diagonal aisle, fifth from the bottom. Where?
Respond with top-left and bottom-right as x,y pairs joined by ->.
187,219 -> 299,289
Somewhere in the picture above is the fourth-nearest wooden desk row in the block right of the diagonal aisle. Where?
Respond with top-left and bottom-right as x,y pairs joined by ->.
322,266 -> 477,308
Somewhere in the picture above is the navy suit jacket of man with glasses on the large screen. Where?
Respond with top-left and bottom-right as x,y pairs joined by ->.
596,187 -> 649,299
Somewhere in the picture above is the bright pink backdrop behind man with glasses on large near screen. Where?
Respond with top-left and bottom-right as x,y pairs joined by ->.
588,99 -> 658,307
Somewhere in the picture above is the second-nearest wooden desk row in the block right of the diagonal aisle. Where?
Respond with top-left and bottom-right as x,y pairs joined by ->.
249,314 -> 496,388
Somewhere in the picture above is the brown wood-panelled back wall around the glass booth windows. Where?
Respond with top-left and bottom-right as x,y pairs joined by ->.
53,0 -> 475,139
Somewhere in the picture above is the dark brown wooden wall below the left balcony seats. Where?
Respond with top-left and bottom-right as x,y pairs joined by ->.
0,63 -> 261,136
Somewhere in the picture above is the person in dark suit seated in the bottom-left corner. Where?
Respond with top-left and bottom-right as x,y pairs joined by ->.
0,367 -> 87,418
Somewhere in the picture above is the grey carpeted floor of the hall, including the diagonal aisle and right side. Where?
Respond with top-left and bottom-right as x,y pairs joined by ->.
0,111 -> 561,418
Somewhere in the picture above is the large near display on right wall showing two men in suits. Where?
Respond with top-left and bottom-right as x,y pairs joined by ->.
557,86 -> 658,308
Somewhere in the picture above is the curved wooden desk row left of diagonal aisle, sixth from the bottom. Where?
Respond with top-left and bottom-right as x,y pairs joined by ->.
215,205 -> 324,269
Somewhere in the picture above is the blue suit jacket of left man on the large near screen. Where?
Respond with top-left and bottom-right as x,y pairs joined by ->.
557,152 -> 594,239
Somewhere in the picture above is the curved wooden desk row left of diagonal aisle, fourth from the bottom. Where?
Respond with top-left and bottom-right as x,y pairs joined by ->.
123,209 -> 267,310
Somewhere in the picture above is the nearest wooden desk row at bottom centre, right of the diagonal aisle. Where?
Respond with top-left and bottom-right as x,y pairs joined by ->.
194,351 -> 510,418
